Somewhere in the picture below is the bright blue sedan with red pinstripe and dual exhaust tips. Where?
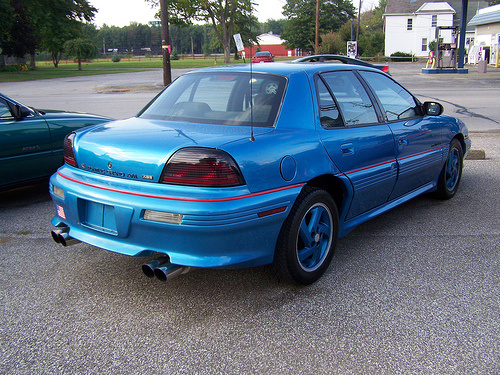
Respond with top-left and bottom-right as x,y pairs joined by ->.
50,63 -> 471,284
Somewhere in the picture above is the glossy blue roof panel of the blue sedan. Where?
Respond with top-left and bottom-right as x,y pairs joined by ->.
188,62 -> 381,76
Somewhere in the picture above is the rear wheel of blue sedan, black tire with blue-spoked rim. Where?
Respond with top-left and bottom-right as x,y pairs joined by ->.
273,187 -> 339,285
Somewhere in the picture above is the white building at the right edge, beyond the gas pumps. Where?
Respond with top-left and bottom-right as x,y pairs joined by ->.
468,4 -> 500,64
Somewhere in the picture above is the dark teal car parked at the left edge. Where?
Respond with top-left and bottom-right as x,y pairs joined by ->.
0,94 -> 110,190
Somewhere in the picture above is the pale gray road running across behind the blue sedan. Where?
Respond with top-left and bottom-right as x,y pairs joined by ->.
0,63 -> 500,131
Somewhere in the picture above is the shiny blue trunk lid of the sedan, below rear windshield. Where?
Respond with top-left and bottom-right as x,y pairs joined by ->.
75,118 -> 273,182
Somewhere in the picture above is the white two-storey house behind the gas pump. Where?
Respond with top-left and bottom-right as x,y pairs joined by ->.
384,0 -> 488,57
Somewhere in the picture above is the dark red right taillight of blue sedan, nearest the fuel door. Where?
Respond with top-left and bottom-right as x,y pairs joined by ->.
160,147 -> 245,187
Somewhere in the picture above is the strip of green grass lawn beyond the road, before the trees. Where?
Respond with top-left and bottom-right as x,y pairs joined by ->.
0,56 -> 296,82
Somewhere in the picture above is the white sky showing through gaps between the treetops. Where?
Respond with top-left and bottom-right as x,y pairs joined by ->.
89,0 -> 378,27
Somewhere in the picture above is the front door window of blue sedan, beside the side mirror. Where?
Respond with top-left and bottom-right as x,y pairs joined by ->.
359,71 -> 419,121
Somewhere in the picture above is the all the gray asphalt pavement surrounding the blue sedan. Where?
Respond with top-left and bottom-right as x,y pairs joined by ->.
0,64 -> 500,374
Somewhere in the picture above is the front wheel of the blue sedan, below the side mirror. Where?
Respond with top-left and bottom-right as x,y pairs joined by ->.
435,139 -> 464,199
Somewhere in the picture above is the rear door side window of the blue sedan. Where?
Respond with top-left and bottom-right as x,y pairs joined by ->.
321,71 -> 378,126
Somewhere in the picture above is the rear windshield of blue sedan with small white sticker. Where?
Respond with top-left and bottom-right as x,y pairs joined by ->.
139,72 -> 286,127
